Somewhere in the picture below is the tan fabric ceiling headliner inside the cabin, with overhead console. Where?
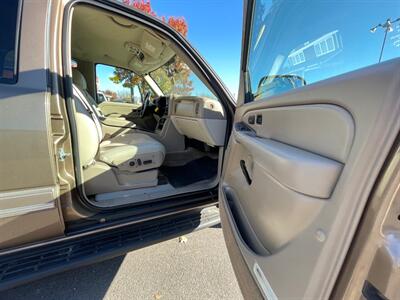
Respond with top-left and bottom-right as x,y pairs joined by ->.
71,5 -> 175,74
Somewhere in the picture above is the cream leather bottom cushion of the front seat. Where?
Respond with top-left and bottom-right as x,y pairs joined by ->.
98,133 -> 165,172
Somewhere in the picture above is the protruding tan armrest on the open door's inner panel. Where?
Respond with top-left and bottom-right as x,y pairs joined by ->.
233,126 -> 343,198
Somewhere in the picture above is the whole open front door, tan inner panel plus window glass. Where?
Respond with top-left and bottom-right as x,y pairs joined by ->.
219,0 -> 400,299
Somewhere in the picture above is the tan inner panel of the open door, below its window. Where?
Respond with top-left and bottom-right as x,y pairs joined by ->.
220,59 -> 400,299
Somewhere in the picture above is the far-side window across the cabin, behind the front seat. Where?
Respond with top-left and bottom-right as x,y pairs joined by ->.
96,64 -> 153,104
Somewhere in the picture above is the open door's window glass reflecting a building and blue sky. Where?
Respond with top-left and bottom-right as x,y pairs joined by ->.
247,0 -> 400,100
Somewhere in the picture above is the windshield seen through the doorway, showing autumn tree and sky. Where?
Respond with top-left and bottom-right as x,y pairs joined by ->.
149,56 -> 216,99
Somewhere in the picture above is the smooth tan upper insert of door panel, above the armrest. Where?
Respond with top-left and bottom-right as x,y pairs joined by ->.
242,104 -> 355,162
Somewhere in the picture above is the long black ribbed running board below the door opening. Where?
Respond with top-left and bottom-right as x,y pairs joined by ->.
0,206 -> 220,290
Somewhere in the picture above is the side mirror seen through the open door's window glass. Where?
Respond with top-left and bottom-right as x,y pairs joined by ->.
255,75 -> 306,97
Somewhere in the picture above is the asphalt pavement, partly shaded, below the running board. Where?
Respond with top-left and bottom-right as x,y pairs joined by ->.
0,226 -> 242,300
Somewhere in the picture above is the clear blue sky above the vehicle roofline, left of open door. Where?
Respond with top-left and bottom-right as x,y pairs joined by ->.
97,0 -> 243,95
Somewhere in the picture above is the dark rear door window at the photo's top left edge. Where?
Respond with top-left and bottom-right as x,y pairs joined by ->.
0,0 -> 20,83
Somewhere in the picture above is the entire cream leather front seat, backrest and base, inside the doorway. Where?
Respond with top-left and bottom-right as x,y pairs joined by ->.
73,69 -> 165,195
